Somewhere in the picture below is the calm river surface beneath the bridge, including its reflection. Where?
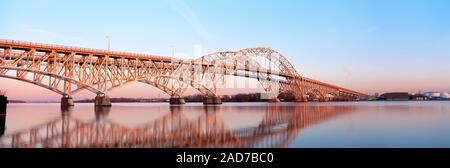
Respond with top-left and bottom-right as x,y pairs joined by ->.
0,101 -> 450,148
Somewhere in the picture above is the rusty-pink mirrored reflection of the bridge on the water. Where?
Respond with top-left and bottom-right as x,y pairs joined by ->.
0,104 -> 355,148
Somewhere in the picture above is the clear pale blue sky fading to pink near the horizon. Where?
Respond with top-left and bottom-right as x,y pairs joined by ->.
0,0 -> 450,100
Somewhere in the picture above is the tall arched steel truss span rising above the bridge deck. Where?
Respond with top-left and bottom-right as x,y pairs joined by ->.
180,48 -> 300,98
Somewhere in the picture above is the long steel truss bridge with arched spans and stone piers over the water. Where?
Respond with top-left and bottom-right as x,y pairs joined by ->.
0,40 -> 367,106
